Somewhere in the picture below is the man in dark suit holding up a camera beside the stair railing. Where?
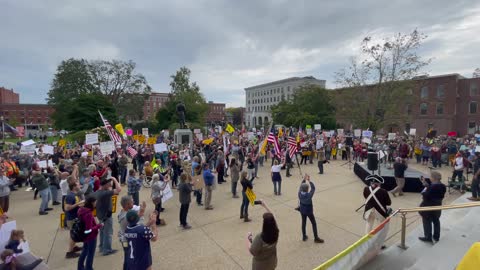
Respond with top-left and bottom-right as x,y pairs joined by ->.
418,171 -> 447,243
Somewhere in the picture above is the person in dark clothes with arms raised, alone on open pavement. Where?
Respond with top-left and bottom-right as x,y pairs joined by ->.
298,174 -> 324,243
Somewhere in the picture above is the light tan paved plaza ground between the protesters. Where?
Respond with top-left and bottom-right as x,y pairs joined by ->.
10,160 -> 458,270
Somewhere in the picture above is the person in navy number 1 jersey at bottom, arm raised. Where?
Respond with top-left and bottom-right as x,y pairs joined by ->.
125,210 -> 158,270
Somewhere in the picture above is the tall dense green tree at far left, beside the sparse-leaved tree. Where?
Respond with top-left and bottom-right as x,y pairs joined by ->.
47,58 -> 96,129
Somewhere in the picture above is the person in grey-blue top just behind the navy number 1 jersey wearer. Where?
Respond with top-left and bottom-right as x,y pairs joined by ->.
117,196 -> 146,270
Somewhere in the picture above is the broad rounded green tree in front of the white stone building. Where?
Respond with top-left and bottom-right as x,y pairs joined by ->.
272,84 -> 335,128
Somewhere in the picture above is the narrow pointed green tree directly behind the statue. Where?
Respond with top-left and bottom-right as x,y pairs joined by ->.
156,67 -> 208,129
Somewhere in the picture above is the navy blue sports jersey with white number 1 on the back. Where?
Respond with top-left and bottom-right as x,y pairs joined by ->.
125,225 -> 154,270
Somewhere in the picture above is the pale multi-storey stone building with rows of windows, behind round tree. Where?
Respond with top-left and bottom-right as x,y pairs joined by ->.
245,76 -> 325,128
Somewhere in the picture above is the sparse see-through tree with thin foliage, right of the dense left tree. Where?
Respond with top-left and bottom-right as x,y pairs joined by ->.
88,60 -> 151,121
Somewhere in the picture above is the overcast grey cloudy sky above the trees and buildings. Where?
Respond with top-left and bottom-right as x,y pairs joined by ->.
0,0 -> 480,106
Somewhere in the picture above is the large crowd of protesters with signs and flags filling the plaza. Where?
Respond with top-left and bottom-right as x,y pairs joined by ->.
0,127 -> 480,270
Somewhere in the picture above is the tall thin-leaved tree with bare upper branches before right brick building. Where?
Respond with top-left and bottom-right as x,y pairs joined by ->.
335,30 -> 431,131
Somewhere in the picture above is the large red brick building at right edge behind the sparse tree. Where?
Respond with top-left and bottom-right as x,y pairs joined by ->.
337,74 -> 480,136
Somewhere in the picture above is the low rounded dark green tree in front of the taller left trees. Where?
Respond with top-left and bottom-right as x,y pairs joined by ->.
65,94 -> 118,132
